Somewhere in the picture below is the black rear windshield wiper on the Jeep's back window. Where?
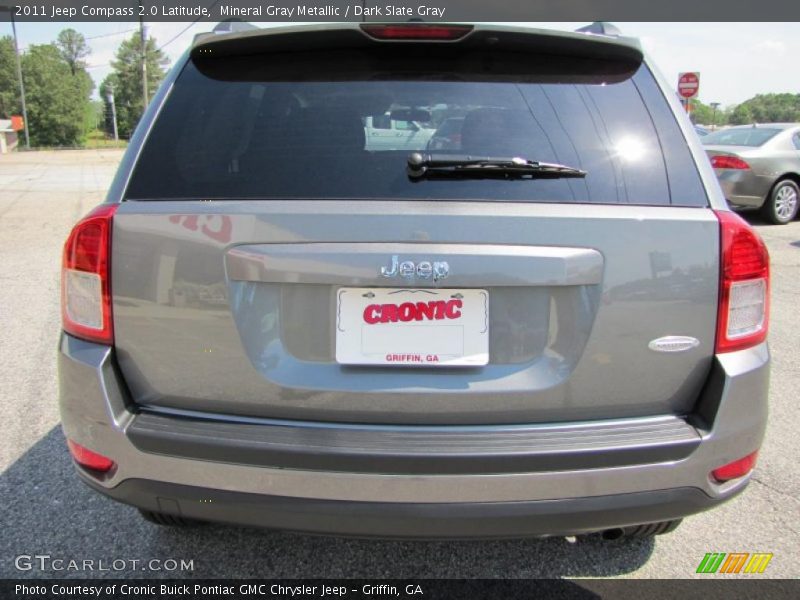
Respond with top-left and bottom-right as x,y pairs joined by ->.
407,152 -> 586,181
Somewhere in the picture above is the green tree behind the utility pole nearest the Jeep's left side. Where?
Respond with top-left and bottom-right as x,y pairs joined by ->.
100,33 -> 169,138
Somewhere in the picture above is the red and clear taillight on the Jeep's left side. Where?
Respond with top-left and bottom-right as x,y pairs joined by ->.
61,204 -> 117,344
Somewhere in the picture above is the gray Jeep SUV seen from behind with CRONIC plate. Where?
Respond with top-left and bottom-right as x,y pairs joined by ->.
59,24 -> 770,538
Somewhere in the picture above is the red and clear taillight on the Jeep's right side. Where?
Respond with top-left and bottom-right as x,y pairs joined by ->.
716,211 -> 769,353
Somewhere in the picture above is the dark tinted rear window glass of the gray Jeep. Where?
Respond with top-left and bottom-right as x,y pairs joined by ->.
127,47 -> 707,206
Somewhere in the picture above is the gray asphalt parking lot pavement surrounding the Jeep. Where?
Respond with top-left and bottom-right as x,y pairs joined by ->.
0,150 -> 800,578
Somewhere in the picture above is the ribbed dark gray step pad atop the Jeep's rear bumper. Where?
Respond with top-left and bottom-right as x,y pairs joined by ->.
126,409 -> 701,475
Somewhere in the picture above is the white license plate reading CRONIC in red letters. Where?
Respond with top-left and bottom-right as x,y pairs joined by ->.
336,288 -> 489,367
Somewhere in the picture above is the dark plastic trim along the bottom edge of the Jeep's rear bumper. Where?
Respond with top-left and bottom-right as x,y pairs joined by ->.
82,473 -> 741,539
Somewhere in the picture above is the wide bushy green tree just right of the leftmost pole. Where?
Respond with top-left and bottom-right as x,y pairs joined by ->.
22,44 -> 91,146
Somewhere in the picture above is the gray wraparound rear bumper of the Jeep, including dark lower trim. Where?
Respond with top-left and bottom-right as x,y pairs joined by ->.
59,335 -> 769,537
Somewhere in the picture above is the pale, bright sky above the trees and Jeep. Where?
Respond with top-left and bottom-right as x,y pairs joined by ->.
0,22 -> 800,107
